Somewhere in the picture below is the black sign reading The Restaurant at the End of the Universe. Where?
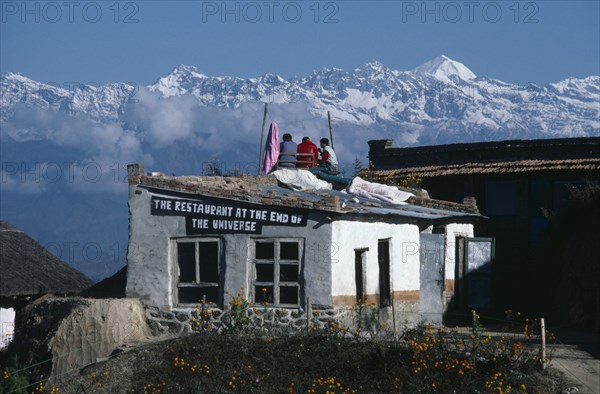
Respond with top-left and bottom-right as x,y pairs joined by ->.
150,197 -> 308,234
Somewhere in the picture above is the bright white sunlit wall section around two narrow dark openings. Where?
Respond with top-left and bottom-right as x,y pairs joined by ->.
331,220 -> 419,297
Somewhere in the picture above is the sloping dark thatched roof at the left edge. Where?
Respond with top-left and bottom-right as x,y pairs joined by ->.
0,220 -> 94,304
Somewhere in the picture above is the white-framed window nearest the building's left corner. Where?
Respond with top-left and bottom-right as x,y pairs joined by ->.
174,238 -> 221,304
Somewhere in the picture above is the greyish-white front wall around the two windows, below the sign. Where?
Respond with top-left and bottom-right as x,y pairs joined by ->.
126,186 -> 334,310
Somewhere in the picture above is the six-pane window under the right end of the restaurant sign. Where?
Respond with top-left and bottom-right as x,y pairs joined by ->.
251,238 -> 303,306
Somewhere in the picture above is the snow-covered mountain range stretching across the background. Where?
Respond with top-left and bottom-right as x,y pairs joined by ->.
0,55 -> 600,140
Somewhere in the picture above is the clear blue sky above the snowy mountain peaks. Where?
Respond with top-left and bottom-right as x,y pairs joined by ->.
0,0 -> 600,84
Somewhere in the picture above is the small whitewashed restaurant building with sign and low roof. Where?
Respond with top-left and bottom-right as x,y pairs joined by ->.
126,164 -> 481,330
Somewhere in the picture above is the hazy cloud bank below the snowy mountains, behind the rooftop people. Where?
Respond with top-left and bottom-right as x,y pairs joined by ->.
2,89 -> 387,194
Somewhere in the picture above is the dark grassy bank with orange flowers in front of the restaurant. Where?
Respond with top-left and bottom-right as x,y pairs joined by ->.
45,331 -> 568,393
